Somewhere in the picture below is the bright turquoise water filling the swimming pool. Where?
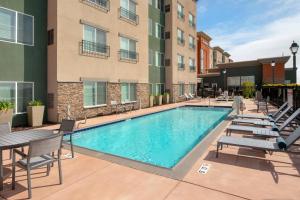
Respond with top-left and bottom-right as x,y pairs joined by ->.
73,107 -> 231,168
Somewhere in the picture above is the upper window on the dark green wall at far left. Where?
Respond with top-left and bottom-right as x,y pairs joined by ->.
0,7 -> 34,46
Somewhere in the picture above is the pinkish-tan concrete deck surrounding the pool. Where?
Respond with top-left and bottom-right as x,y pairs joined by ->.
0,100 -> 300,200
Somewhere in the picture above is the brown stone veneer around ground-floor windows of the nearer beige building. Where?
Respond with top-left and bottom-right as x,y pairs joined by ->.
57,82 -> 149,121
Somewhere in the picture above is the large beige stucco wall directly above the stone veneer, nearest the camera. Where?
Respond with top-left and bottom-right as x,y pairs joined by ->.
52,0 -> 148,83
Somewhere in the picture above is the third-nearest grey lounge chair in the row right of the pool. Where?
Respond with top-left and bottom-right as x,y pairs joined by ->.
232,106 -> 293,126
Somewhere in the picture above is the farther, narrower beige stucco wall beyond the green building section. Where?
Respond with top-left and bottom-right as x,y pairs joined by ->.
166,0 -> 197,89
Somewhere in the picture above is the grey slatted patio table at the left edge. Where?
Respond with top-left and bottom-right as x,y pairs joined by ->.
0,130 -> 53,191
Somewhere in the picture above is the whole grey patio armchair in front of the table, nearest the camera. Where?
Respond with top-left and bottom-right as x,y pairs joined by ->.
12,134 -> 63,198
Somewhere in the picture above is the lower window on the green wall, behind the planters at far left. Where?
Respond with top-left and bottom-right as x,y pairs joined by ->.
0,81 -> 34,114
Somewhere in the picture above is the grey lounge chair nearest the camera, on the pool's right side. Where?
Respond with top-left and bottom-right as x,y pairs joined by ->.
216,127 -> 300,158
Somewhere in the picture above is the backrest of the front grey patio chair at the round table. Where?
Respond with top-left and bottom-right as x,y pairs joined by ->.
28,134 -> 63,159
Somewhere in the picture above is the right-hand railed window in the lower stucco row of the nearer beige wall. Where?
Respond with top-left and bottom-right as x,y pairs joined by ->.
120,37 -> 138,61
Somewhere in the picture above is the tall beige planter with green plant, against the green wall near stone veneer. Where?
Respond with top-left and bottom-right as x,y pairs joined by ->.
27,100 -> 45,127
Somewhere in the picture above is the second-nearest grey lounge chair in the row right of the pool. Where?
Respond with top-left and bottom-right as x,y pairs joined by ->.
226,108 -> 300,137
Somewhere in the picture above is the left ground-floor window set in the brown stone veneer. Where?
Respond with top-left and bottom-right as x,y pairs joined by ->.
83,81 -> 106,107
